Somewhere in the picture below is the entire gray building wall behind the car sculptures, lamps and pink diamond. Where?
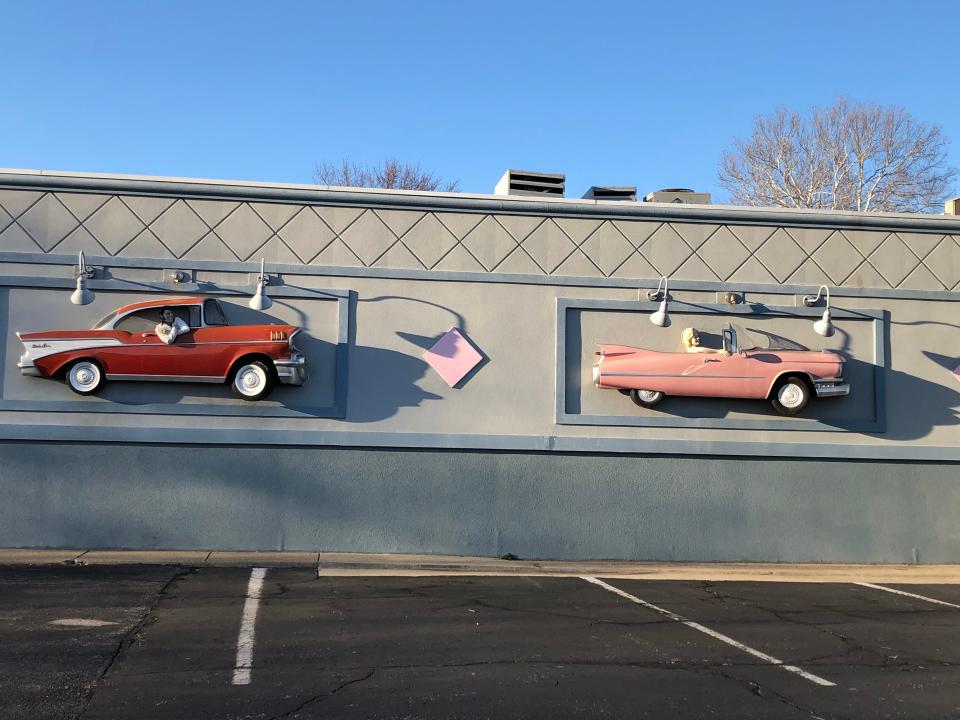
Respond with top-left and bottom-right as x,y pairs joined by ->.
0,172 -> 960,562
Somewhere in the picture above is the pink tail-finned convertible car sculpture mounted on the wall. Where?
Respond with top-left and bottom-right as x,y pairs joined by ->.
593,325 -> 850,415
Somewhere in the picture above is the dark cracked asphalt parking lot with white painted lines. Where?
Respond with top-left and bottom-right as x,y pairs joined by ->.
0,566 -> 960,720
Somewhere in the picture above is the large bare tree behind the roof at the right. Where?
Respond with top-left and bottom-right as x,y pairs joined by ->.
718,98 -> 957,212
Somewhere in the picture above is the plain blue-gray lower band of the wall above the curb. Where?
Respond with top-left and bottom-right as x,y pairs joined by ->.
0,442 -> 960,563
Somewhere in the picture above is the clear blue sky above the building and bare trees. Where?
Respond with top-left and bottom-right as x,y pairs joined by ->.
0,0 -> 960,199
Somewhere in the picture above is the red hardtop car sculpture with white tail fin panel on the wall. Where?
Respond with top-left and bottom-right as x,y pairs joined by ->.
17,297 -> 307,400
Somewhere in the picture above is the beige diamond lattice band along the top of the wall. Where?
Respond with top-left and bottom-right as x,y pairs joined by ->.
0,190 -> 960,290
